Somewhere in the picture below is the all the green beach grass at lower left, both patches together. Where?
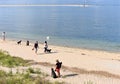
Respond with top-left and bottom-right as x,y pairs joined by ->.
0,50 -> 65,84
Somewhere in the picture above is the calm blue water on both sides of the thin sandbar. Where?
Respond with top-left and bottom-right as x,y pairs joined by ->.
0,0 -> 120,52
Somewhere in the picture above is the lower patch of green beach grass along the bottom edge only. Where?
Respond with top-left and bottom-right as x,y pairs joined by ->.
0,70 -> 64,84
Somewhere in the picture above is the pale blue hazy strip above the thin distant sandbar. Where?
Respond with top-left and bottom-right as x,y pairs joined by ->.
0,0 -> 120,4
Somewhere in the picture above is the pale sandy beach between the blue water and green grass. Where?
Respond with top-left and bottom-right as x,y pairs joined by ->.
0,40 -> 120,84
